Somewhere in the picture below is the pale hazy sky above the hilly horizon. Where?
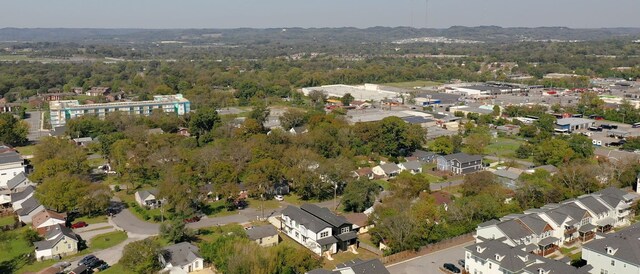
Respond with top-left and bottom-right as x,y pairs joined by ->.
0,0 -> 640,29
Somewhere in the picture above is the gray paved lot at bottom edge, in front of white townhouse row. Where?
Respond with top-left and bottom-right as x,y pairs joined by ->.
387,241 -> 473,274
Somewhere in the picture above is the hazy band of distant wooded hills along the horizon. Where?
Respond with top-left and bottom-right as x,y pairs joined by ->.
0,26 -> 640,44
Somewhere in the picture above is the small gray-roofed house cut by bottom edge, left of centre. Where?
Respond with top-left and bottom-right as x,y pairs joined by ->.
160,242 -> 204,273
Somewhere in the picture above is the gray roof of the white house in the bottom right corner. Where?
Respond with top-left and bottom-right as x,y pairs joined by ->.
582,223 -> 640,265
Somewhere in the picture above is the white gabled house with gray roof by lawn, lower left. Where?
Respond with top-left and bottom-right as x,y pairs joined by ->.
33,224 -> 78,261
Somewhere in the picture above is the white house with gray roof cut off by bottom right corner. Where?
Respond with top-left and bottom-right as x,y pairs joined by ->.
582,224 -> 640,273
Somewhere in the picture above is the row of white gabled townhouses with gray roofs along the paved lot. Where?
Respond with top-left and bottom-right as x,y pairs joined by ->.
476,188 -> 638,256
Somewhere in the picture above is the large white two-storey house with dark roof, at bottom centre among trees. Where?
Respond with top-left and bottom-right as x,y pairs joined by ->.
280,204 -> 358,258
